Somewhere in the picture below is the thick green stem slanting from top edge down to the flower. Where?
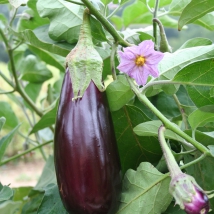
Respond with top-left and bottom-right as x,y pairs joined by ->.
82,0 -> 131,47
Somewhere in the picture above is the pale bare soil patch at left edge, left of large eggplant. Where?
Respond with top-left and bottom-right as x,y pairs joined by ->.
0,160 -> 45,187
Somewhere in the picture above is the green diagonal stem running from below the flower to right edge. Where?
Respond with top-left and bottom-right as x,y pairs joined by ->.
127,76 -> 212,156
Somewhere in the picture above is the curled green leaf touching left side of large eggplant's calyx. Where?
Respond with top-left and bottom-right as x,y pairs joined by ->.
20,25 -> 74,57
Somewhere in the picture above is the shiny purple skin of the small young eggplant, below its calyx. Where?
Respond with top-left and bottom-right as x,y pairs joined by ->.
184,186 -> 209,214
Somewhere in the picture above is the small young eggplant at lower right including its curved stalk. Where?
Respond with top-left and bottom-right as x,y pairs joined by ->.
158,126 -> 209,214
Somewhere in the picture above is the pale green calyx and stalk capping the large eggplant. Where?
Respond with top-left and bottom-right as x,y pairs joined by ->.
66,8 -> 104,100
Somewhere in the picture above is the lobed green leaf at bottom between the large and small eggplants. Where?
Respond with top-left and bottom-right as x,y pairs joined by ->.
117,163 -> 172,214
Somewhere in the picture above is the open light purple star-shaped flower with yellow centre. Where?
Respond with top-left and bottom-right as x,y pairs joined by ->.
117,40 -> 164,85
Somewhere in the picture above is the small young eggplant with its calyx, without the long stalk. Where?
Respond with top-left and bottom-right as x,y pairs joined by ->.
170,173 -> 209,214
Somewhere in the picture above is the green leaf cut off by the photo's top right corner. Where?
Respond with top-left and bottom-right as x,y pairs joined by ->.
178,0 -> 214,30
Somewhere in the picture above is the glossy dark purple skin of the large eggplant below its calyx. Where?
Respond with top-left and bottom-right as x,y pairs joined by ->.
54,69 -> 121,214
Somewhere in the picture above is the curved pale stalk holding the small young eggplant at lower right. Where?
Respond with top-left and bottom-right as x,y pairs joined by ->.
158,125 -> 182,177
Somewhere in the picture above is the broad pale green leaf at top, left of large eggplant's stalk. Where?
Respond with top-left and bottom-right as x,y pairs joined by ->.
37,0 -> 83,44
